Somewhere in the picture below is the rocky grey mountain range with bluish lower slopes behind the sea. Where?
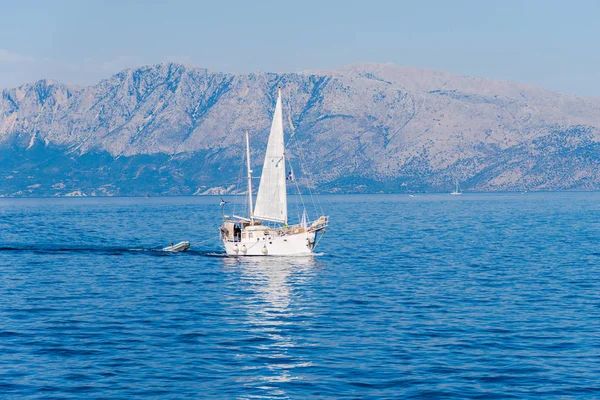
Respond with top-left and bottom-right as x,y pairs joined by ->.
0,63 -> 600,196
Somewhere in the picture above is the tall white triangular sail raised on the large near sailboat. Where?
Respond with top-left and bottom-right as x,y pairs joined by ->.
254,91 -> 287,224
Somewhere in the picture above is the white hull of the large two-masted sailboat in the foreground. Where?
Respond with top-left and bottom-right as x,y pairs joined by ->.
223,228 -> 316,256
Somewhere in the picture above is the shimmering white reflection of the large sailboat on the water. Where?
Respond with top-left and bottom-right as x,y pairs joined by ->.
222,256 -> 316,390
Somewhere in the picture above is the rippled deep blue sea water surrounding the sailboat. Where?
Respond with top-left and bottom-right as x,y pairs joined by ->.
0,193 -> 600,399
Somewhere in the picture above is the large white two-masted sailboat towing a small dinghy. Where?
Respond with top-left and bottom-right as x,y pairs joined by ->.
219,89 -> 329,256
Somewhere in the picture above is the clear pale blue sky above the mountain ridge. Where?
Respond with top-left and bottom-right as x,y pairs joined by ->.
0,0 -> 600,96
